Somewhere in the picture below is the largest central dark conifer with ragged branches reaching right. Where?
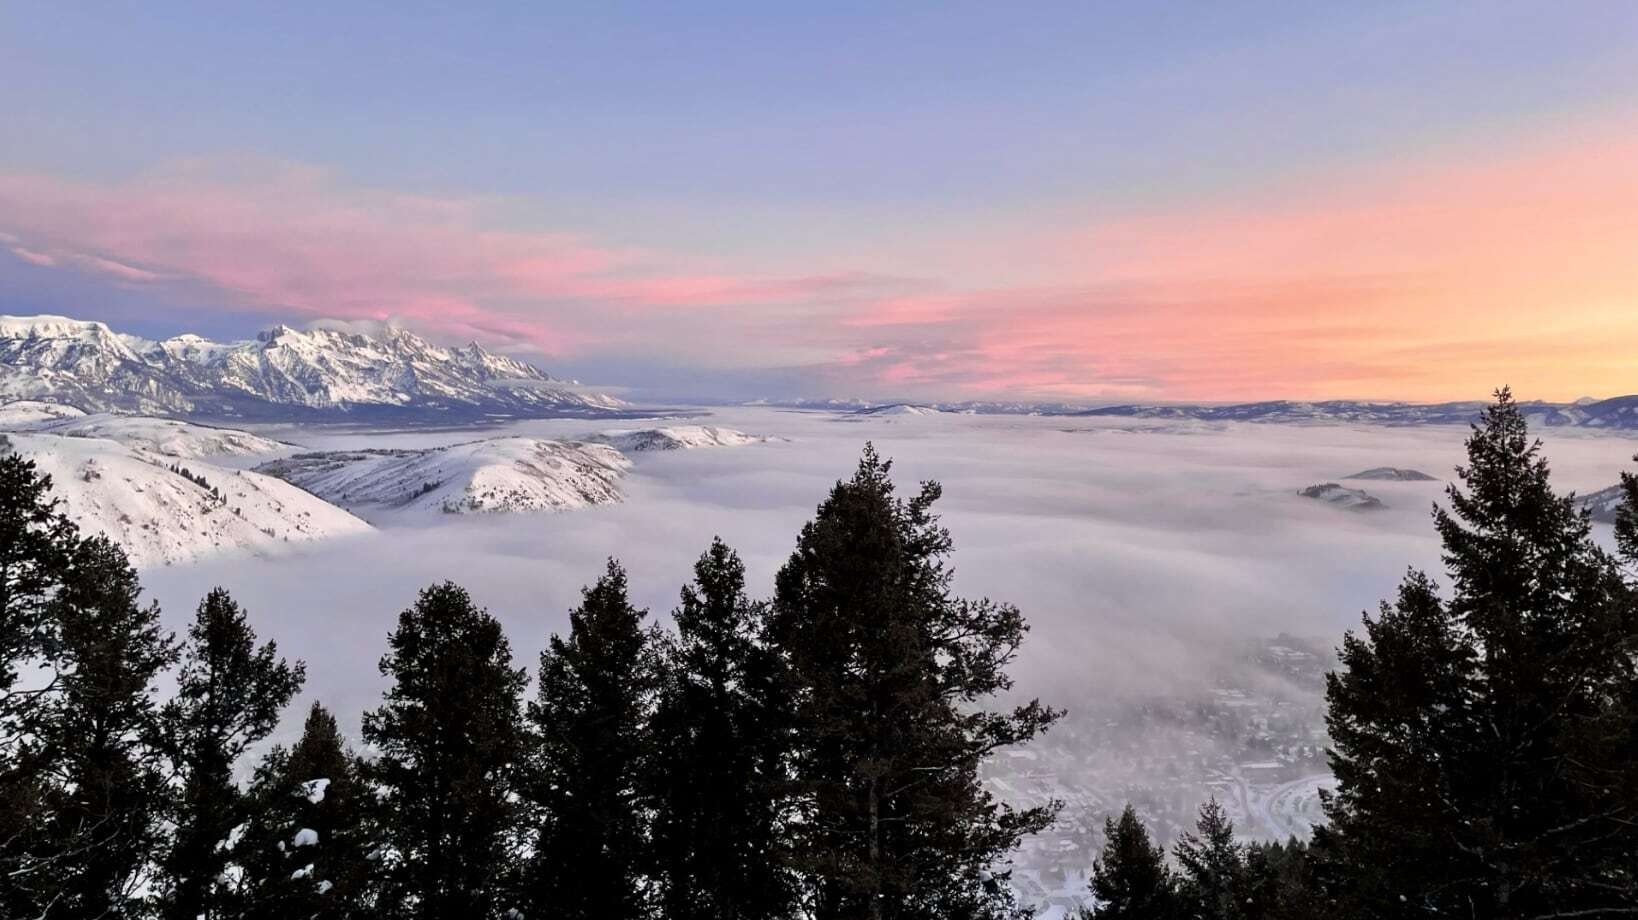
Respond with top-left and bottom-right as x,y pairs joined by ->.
771,445 -> 1058,920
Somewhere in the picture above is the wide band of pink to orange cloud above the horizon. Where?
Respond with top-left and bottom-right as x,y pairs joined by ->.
0,129 -> 1638,399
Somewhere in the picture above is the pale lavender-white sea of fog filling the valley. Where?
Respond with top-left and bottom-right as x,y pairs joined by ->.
143,408 -> 1638,738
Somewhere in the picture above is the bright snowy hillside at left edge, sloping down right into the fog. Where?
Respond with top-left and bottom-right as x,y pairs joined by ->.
0,432 -> 370,566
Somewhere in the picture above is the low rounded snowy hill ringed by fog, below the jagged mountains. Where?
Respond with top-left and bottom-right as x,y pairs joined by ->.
259,437 -> 631,514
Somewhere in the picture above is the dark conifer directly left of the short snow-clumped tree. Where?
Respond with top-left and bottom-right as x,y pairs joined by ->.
162,588 -> 306,920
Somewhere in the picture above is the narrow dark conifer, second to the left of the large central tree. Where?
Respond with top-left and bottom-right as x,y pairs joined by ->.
529,560 -> 657,920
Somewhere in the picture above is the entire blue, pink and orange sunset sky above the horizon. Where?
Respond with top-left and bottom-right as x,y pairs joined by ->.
0,0 -> 1638,401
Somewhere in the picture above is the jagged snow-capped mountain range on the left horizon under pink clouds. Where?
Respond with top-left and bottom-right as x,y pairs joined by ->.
0,316 -> 626,419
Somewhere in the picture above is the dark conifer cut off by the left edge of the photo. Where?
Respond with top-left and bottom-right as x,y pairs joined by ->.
0,439 -> 77,917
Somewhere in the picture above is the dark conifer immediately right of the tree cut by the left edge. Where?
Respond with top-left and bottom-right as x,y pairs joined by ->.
29,535 -> 177,920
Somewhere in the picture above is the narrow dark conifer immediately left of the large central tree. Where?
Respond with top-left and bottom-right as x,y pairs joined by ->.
652,540 -> 791,920
